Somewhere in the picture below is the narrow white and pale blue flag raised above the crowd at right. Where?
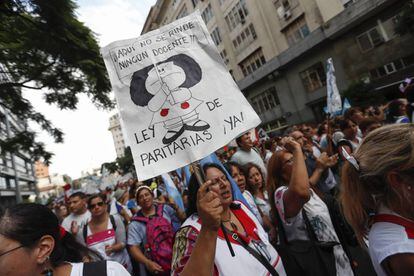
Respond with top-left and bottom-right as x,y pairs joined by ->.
326,58 -> 342,115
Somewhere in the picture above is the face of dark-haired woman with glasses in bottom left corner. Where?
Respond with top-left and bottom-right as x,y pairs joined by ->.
0,235 -> 41,276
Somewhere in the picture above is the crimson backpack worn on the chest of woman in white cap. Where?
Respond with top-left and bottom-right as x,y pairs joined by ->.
132,204 -> 174,272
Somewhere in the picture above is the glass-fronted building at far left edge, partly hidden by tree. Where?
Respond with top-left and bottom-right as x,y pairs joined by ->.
0,64 -> 36,206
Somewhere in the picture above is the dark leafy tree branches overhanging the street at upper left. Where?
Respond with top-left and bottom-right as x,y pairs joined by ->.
0,0 -> 113,162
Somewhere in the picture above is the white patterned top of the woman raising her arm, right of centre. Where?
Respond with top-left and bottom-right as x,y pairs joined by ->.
274,186 -> 354,276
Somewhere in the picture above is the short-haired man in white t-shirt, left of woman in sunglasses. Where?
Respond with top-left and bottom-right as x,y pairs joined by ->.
62,192 -> 91,235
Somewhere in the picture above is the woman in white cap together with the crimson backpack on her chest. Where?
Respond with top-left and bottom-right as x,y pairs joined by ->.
127,185 -> 179,276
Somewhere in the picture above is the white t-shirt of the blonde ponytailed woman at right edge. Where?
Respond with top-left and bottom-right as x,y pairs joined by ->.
368,206 -> 414,276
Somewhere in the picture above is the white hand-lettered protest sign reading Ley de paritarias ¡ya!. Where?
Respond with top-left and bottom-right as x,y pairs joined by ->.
101,11 -> 260,180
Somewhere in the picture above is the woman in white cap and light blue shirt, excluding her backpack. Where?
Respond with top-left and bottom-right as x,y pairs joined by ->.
127,185 -> 178,276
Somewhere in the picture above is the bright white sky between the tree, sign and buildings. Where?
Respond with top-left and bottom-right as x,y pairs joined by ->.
24,0 -> 156,178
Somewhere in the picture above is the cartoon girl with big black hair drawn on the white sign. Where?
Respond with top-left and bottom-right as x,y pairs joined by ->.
130,54 -> 210,144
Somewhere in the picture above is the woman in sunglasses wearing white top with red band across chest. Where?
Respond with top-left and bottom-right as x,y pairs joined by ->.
78,194 -> 132,272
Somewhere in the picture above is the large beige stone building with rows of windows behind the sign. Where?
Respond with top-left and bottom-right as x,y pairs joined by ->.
142,0 -> 414,131
